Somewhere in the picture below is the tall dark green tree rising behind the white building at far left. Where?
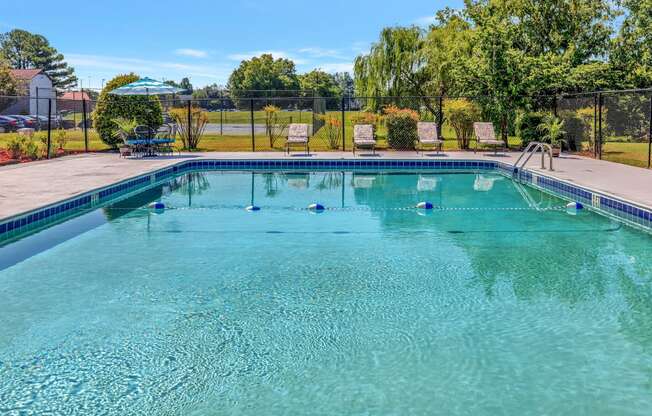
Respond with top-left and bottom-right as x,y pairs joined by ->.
0,29 -> 77,89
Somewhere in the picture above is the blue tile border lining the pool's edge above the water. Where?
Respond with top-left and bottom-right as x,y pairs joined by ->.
0,159 -> 652,239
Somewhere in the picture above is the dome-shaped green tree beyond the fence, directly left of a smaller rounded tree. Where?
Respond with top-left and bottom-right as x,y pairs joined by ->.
227,54 -> 299,98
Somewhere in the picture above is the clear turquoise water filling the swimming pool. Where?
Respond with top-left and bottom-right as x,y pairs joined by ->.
0,172 -> 652,415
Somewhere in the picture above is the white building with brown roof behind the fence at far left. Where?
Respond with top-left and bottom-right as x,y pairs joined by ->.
5,69 -> 57,116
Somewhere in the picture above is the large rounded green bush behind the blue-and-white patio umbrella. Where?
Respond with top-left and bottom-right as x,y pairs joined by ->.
92,74 -> 163,148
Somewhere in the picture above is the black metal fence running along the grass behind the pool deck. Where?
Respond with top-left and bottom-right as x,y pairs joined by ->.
0,89 -> 652,168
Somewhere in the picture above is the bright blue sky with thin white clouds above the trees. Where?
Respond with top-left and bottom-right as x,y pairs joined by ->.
0,0 -> 463,88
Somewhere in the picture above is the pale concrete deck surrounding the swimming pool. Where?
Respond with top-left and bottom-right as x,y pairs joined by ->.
0,152 -> 652,220
